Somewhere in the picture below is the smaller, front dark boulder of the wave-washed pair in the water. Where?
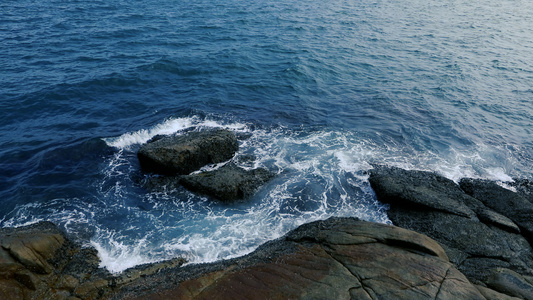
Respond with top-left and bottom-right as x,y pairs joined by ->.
179,163 -> 273,202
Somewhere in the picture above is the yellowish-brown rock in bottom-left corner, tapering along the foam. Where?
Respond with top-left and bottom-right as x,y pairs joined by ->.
0,222 -> 184,300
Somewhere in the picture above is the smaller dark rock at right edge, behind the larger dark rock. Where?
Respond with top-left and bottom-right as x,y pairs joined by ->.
459,178 -> 533,243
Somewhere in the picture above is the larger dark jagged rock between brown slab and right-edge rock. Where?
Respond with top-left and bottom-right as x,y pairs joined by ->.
370,167 -> 533,285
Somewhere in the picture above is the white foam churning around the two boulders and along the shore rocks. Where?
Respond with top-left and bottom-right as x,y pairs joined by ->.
80,117 -> 532,272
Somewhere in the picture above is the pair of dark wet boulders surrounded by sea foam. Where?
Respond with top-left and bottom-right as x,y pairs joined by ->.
137,129 -> 273,202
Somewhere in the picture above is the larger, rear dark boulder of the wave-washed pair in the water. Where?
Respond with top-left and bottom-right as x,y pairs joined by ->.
137,129 -> 239,175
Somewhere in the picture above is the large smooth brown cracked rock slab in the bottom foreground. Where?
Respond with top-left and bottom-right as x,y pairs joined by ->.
109,218 -> 485,299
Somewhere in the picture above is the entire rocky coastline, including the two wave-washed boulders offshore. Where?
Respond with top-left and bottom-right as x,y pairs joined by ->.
0,130 -> 533,300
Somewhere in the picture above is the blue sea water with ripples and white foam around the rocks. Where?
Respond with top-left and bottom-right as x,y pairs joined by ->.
0,0 -> 533,272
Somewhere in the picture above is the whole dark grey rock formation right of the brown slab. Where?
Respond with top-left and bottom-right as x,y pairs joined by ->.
369,166 -> 533,299
